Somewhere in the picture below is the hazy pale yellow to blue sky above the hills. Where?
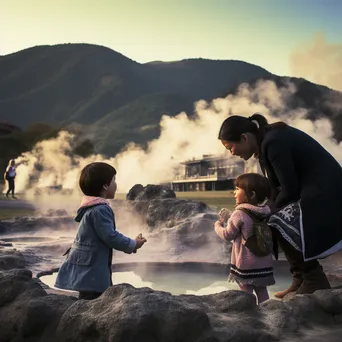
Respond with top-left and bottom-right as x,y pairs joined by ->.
0,0 -> 342,75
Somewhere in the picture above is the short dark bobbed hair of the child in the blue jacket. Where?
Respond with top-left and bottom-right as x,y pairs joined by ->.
79,162 -> 116,197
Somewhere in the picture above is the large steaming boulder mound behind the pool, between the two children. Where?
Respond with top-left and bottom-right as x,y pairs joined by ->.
127,184 -> 222,250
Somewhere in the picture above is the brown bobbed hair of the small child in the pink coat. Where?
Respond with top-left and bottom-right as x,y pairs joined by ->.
235,173 -> 271,204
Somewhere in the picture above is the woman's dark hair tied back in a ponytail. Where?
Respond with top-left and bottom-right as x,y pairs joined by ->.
218,113 -> 287,147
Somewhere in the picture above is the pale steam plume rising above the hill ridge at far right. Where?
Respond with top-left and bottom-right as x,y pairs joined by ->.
290,34 -> 342,91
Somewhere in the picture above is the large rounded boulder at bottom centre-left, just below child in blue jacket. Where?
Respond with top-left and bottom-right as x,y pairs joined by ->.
57,284 -> 211,342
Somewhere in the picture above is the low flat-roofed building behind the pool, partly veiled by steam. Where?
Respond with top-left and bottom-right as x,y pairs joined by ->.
171,153 -> 260,191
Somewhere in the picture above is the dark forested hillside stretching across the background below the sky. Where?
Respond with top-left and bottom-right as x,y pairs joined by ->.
0,44 -> 342,155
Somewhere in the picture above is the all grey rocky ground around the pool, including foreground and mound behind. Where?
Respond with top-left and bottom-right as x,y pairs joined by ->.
0,187 -> 342,342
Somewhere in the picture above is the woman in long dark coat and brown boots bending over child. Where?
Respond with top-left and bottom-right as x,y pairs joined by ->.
219,114 -> 342,298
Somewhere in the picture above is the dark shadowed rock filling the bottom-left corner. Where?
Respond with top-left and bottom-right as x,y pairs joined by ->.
0,269 -> 75,342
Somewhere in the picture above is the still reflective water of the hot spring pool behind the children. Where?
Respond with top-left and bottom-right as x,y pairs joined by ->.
40,263 -> 298,296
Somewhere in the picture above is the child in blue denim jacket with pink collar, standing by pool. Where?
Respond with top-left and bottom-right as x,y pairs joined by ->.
55,162 -> 146,299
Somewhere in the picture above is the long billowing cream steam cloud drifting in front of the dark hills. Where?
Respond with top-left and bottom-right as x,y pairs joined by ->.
9,78 -> 342,201
